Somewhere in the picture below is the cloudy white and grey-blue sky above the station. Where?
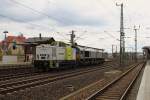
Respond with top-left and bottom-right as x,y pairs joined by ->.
0,0 -> 150,52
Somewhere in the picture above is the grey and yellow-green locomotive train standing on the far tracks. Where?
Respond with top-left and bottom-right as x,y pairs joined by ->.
34,41 -> 104,69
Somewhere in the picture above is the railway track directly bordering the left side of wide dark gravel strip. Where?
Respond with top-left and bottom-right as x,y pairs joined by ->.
0,65 -> 116,95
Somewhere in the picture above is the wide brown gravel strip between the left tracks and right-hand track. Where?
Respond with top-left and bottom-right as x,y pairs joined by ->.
0,62 -> 134,100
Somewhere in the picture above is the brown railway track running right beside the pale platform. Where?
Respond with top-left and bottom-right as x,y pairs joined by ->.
86,64 -> 143,100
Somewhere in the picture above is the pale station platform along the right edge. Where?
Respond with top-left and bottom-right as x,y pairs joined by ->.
136,60 -> 150,100
